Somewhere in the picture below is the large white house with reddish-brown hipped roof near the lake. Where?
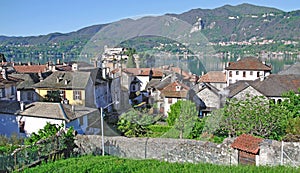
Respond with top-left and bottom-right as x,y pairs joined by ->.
225,57 -> 272,85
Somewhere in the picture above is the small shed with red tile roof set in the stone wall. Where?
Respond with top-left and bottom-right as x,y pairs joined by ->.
231,134 -> 263,165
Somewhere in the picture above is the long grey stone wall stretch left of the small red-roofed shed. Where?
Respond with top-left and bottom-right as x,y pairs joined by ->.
76,135 -> 237,165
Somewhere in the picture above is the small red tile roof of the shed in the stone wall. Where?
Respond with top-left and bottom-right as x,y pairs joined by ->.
231,134 -> 263,154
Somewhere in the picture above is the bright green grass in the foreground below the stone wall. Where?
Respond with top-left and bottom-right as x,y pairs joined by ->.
24,156 -> 300,173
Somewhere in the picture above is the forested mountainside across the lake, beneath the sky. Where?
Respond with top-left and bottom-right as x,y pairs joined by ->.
0,4 -> 300,62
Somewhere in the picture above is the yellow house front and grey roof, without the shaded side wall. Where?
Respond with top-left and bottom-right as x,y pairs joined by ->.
34,69 -> 98,107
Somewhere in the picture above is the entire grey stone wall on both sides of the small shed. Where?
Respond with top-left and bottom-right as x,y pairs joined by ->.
75,135 -> 300,166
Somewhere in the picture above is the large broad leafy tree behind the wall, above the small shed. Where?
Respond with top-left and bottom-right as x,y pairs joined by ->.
220,96 -> 291,140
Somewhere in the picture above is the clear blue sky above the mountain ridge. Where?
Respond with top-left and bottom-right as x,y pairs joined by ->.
0,0 -> 300,36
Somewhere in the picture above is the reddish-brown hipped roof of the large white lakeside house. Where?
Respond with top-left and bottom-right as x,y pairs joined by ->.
225,57 -> 271,71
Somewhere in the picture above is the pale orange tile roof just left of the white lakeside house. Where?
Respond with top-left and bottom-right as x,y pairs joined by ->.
199,71 -> 226,83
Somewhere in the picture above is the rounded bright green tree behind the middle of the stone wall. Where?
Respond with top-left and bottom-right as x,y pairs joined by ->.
167,100 -> 197,139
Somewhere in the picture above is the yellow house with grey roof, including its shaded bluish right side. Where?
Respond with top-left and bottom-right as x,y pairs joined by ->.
33,68 -> 112,108
